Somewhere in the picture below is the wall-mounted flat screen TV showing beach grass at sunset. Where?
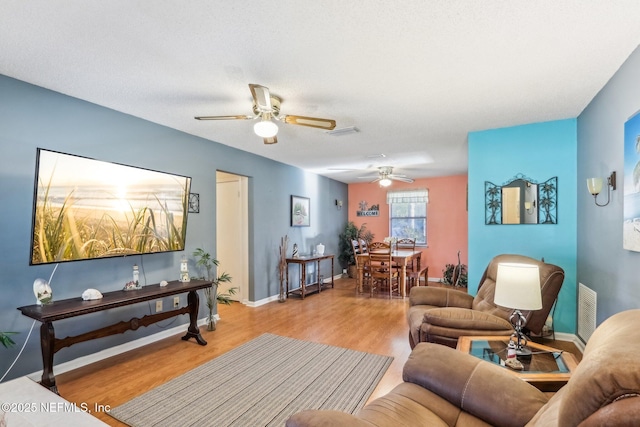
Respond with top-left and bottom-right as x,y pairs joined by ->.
29,148 -> 191,265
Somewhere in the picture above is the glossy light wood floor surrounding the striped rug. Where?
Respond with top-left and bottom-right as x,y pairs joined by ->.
56,279 -> 578,426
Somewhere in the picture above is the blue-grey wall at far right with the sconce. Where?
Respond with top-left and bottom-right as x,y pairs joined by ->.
577,47 -> 640,324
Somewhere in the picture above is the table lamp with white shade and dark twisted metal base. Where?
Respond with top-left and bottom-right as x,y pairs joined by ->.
493,263 -> 542,357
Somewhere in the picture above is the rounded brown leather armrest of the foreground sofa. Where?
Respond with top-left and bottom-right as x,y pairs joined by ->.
403,343 -> 548,426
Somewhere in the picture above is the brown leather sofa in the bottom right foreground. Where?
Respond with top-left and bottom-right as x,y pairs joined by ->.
286,309 -> 640,427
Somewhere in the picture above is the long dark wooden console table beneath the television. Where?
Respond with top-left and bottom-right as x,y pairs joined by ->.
18,280 -> 211,393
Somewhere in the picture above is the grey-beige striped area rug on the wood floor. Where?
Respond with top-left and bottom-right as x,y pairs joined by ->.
109,334 -> 393,427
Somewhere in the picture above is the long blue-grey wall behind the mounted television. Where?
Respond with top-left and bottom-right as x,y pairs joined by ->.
0,75 -> 348,379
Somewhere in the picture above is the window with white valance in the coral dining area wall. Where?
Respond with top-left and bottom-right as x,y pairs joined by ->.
387,189 -> 429,246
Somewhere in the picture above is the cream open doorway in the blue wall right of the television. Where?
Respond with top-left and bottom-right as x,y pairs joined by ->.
216,171 -> 249,304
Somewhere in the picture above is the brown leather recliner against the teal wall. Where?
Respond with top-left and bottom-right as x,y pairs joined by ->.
407,254 -> 564,348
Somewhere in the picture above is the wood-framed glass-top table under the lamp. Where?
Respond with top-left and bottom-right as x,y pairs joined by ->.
457,336 -> 578,391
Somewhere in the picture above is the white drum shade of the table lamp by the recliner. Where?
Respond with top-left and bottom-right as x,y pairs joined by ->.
493,263 -> 542,310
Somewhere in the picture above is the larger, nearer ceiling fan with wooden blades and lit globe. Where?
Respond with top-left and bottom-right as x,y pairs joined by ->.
195,84 -> 336,144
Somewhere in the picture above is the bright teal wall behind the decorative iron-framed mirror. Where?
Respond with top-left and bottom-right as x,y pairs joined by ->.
469,119 -> 577,333
